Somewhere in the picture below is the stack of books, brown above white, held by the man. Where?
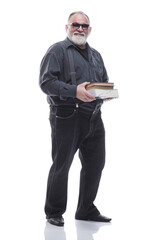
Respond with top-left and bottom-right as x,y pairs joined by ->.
86,82 -> 118,99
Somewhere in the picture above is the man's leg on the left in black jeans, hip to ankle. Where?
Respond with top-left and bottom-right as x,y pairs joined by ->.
45,106 -> 77,218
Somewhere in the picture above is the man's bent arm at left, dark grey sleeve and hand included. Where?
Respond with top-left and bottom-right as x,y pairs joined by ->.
39,53 -> 95,102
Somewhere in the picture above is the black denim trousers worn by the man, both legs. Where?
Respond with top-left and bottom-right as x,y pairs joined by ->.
45,102 -> 105,218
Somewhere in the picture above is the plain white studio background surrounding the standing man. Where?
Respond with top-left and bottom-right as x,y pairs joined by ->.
0,0 -> 160,240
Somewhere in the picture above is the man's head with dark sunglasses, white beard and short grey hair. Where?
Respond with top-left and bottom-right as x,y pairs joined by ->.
66,12 -> 91,48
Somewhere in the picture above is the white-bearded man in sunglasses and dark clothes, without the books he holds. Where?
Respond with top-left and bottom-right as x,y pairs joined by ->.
40,12 -> 111,226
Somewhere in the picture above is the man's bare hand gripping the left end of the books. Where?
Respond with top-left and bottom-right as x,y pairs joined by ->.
76,82 -> 96,102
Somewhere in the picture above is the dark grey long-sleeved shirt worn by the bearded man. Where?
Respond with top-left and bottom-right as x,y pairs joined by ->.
39,38 -> 108,105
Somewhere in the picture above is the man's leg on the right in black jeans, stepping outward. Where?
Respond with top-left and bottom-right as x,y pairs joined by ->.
76,113 -> 105,219
